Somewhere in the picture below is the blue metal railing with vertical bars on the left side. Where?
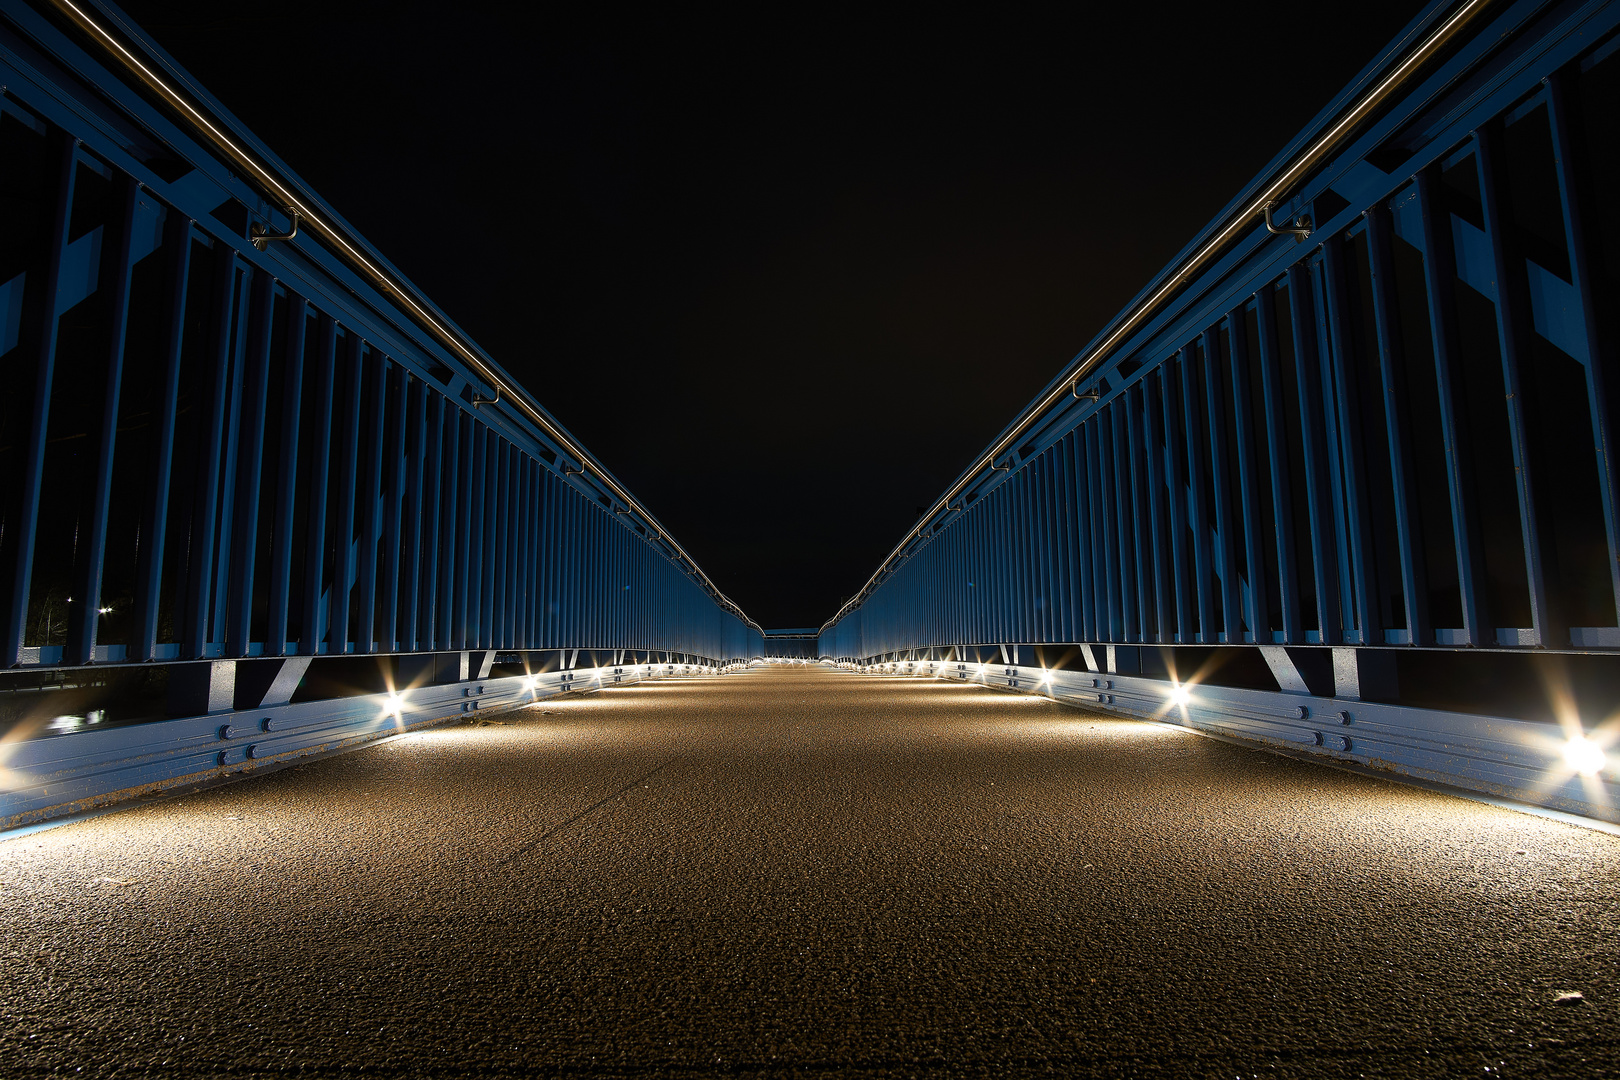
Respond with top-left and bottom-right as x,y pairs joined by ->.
0,0 -> 763,819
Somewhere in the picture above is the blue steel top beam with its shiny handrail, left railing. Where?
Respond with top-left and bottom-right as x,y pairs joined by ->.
38,0 -> 760,630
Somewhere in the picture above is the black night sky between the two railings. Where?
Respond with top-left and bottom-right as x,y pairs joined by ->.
125,0 -> 1419,627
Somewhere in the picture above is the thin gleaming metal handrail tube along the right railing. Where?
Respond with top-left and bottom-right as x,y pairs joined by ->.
821,0 -> 1492,633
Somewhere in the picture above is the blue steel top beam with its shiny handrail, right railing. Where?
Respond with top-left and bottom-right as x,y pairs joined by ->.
829,0 -> 1497,631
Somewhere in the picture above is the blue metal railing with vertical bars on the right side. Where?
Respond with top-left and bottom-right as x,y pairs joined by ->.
820,0 -> 1620,813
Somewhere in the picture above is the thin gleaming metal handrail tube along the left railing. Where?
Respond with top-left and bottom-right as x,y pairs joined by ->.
52,0 -> 760,630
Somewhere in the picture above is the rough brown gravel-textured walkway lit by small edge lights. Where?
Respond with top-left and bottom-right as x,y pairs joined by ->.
0,667 -> 1620,1077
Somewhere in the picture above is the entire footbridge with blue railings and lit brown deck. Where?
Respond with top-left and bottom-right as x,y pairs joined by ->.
0,0 -> 1620,1077
